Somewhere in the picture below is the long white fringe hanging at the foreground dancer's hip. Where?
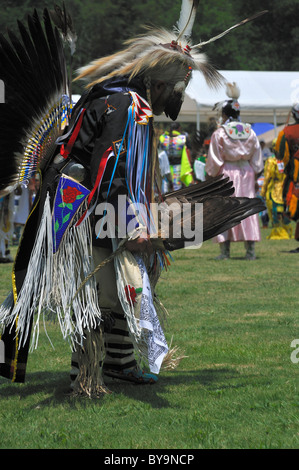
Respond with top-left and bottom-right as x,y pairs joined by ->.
0,194 -> 101,351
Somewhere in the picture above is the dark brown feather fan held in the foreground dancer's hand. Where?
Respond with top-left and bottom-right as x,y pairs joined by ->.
152,175 -> 265,251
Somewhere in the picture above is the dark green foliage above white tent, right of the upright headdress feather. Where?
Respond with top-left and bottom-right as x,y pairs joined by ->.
194,0 -> 299,71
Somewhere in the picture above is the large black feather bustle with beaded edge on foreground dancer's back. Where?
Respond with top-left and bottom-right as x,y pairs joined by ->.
0,9 -> 70,195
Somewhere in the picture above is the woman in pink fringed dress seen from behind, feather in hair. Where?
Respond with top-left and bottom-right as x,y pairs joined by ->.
206,84 -> 263,260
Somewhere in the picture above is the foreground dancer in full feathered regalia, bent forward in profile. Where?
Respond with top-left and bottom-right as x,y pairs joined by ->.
0,1 -> 268,396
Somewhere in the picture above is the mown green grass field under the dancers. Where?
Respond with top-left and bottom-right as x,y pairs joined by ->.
0,229 -> 299,449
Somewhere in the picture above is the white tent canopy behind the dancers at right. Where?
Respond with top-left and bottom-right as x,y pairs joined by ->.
155,70 -> 299,129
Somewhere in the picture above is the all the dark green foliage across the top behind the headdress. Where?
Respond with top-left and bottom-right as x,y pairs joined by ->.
0,0 -> 299,81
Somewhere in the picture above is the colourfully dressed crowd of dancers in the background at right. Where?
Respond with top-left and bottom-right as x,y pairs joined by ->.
158,100 -> 299,259
